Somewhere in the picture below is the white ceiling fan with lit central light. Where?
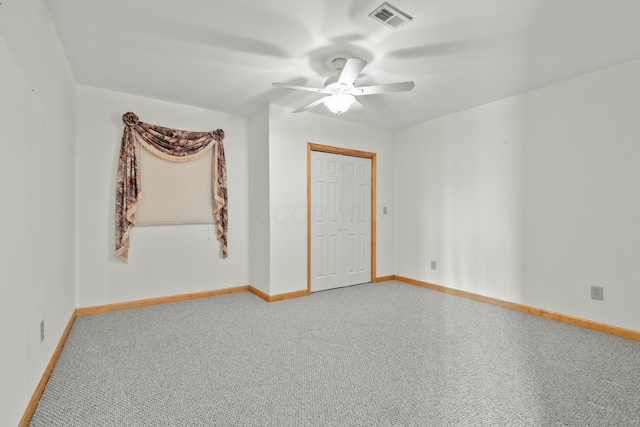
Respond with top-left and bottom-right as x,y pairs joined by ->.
273,58 -> 415,114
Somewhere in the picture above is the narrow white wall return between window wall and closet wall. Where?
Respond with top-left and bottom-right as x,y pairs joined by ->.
249,105 -> 271,294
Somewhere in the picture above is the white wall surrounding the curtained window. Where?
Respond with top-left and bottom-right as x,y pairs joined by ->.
72,85 -> 249,307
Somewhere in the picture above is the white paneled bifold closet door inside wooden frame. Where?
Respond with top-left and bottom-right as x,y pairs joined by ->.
311,151 -> 371,292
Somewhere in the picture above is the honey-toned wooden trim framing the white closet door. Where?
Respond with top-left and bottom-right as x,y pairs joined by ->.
307,142 -> 377,293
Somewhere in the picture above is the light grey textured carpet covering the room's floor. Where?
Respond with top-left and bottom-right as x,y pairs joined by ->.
30,282 -> 640,427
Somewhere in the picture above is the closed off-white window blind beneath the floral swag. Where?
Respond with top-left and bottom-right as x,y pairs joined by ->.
135,142 -> 213,226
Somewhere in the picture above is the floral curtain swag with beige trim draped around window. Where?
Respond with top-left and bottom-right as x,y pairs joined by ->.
116,112 -> 228,262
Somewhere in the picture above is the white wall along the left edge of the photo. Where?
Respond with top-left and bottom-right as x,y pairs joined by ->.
0,0 -> 75,427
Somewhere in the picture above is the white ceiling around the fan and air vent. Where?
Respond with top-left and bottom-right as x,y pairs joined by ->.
46,0 -> 640,129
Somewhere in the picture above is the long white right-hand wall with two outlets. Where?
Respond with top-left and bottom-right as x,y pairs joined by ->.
395,61 -> 640,330
